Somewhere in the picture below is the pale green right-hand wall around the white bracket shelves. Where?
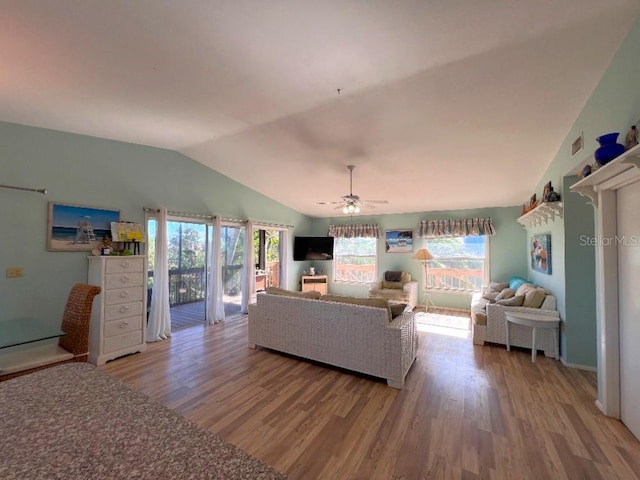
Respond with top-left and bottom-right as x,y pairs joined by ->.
536,15 -> 640,367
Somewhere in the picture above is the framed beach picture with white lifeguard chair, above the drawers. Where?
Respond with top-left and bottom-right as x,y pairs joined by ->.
47,202 -> 120,252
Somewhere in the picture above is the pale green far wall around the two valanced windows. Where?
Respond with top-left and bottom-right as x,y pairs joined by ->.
313,207 -> 527,309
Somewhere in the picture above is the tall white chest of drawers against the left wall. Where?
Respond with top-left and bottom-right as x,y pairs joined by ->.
89,255 -> 147,365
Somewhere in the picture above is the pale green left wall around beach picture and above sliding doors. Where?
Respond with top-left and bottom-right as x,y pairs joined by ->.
0,123 -> 310,324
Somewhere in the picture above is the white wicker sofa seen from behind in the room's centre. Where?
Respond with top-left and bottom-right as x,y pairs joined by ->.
249,290 -> 418,389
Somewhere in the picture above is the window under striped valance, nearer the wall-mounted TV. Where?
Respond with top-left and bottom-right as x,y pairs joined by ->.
333,237 -> 378,283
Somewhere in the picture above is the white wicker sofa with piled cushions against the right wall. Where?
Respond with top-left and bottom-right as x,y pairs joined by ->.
471,282 -> 559,357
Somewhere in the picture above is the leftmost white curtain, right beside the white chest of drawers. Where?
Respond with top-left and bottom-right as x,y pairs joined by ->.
147,208 -> 171,342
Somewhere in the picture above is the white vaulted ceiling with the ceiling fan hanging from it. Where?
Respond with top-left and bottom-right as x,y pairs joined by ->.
0,0 -> 640,217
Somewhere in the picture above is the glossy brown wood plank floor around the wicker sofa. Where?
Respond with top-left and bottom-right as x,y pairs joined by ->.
101,317 -> 640,480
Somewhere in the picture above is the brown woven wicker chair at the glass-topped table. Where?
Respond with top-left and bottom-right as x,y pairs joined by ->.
0,283 -> 100,381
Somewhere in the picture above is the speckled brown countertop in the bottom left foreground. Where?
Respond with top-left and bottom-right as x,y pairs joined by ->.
0,363 -> 285,480
